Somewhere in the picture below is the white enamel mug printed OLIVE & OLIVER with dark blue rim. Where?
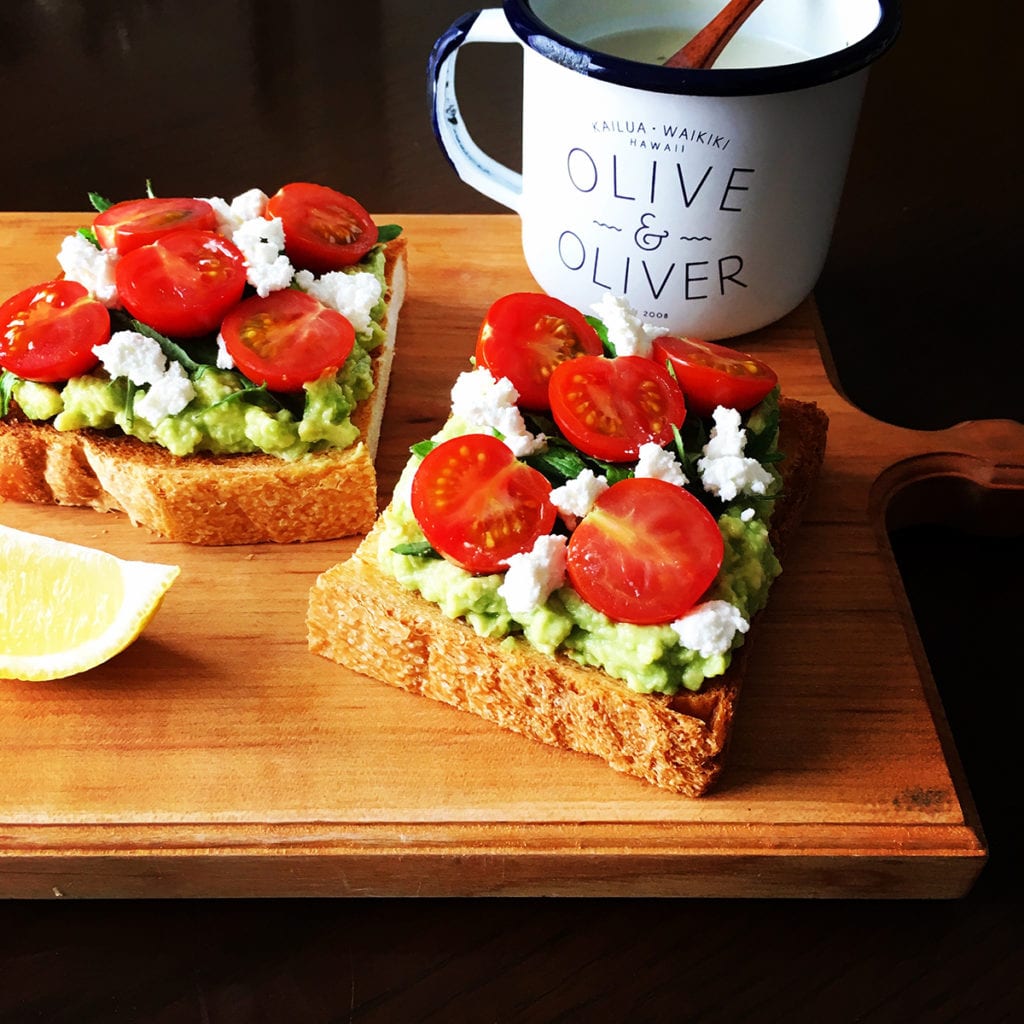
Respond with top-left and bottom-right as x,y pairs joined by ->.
429,0 -> 900,340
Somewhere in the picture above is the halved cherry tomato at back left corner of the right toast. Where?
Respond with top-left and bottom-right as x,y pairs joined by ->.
476,292 -> 603,410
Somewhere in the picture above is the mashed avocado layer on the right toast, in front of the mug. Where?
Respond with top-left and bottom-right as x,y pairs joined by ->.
377,392 -> 780,694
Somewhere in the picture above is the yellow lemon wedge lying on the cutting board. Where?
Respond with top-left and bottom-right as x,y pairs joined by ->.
0,525 -> 180,680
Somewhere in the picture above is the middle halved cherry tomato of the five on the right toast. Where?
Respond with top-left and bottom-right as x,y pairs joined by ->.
549,355 -> 686,462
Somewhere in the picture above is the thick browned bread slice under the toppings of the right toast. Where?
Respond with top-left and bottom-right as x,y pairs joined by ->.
307,399 -> 827,797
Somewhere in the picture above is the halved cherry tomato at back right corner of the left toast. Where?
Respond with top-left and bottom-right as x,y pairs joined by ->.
266,181 -> 377,273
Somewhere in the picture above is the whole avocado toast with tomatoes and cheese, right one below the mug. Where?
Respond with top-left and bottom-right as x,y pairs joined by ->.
308,292 -> 827,796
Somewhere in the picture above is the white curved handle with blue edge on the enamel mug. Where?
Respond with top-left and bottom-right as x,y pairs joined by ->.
428,7 -> 522,213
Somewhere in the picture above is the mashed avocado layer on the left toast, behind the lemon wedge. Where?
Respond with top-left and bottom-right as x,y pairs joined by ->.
5,247 -> 386,460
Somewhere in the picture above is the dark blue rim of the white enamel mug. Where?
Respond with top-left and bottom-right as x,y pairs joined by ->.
504,0 -> 901,96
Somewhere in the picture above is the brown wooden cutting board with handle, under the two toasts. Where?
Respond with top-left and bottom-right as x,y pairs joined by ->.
0,214 -> 1024,897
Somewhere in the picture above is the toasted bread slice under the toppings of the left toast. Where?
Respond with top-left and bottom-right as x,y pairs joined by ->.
0,236 -> 407,545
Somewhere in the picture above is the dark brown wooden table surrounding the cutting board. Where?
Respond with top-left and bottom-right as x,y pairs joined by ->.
0,0 -> 1024,1024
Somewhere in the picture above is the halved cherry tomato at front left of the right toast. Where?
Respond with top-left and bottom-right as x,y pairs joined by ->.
412,434 -> 555,572
